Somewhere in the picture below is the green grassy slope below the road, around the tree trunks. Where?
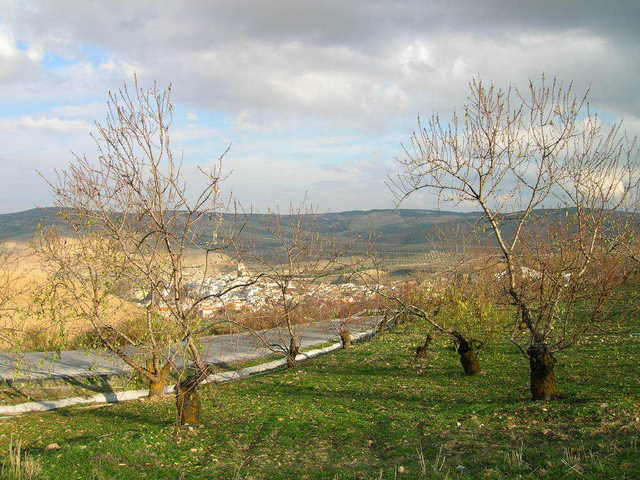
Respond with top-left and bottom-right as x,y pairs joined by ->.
0,318 -> 640,480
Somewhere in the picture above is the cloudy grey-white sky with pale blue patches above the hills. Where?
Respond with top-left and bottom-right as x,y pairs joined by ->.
0,0 -> 640,213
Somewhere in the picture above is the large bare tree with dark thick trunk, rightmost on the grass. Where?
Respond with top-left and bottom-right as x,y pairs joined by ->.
391,76 -> 638,399
